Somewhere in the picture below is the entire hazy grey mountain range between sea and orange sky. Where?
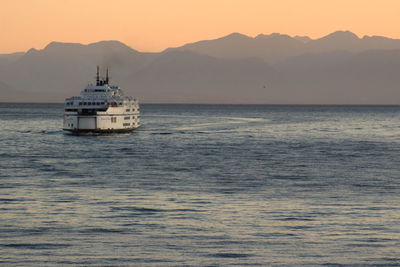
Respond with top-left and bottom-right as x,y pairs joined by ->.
0,31 -> 400,104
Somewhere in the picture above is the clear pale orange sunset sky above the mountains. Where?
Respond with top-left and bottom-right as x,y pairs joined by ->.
0,0 -> 400,54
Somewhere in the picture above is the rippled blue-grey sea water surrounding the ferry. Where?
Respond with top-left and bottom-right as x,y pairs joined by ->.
0,104 -> 400,266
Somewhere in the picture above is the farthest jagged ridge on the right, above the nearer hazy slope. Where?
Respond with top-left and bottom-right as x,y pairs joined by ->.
169,31 -> 400,62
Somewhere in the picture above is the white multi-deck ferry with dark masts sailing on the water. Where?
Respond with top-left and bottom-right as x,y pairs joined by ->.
63,67 -> 140,134
